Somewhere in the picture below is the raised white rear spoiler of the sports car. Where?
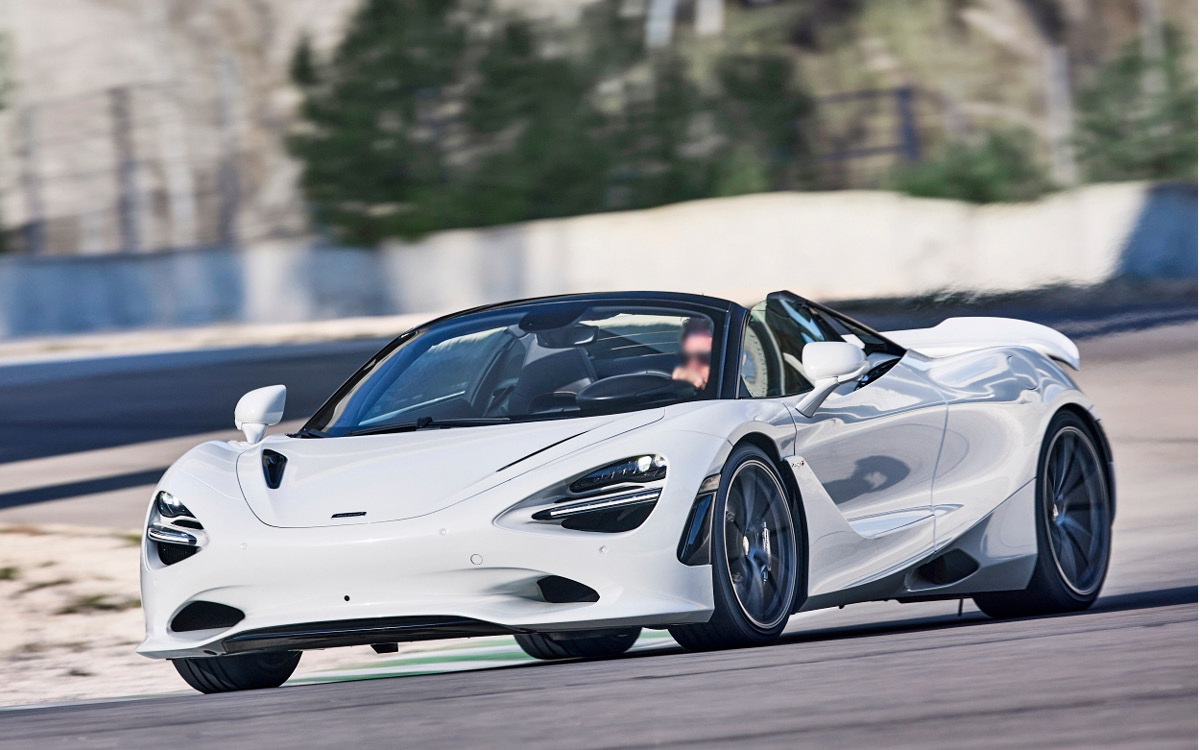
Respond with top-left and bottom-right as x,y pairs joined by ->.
883,318 -> 1079,370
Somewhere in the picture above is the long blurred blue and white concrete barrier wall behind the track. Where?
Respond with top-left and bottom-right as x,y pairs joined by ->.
0,184 -> 1196,337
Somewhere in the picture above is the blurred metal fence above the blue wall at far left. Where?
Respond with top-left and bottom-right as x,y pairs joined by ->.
5,84 -> 241,254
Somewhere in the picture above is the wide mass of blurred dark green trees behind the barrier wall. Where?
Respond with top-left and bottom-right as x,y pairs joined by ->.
290,0 -> 812,244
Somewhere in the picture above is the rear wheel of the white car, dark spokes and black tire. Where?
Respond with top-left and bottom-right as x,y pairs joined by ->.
974,412 -> 1112,619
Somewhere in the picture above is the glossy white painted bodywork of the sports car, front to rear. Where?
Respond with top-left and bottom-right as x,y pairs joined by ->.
138,312 -> 1091,659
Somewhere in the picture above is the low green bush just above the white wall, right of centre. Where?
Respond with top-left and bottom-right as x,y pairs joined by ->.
890,130 -> 1050,203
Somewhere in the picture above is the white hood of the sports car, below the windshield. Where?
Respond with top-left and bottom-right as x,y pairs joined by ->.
238,409 -> 664,527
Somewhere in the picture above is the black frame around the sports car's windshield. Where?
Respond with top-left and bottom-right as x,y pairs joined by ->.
300,293 -> 748,437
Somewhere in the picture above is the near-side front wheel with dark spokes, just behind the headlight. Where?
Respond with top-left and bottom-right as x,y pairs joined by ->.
668,445 -> 800,650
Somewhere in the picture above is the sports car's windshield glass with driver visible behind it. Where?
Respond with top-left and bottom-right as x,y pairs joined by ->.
301,301 -> 725,437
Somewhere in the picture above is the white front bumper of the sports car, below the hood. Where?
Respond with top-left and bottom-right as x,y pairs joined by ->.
137,433 -> 727,659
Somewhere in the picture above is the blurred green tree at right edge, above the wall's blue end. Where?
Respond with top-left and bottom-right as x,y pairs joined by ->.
1078,29 -> 1196,181
